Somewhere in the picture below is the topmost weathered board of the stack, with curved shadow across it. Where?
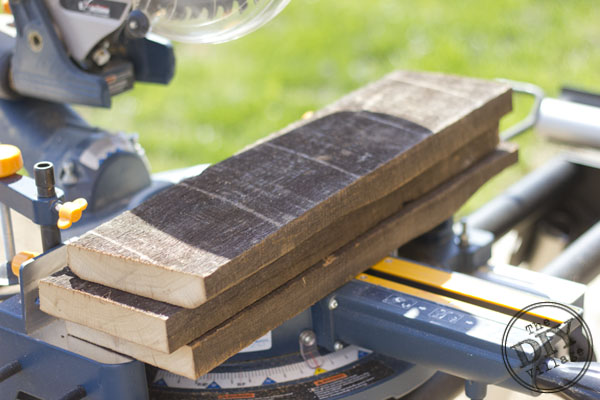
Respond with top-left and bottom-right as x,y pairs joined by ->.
67,73 -> 511,308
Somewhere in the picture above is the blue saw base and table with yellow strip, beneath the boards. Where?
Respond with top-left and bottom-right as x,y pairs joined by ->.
1,216 -> 596,399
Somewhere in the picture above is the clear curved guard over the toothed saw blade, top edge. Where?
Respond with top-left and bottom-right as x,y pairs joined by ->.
133,0 -> 290,43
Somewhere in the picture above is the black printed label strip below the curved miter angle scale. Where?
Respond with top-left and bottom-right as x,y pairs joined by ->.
150,357 -> 395,400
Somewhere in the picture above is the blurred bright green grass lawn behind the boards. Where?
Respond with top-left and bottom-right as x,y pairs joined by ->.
80,0 -> 600,211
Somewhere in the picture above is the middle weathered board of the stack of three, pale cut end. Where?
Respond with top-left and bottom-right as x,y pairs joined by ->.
40,128 -> 498,353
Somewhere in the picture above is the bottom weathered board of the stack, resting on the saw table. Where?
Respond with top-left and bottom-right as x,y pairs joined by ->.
67,144 -> 517,379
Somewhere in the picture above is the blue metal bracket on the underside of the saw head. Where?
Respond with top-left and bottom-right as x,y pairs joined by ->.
10,0 -> 175,107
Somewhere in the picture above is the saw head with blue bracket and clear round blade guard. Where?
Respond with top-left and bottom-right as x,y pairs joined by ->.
0,0 -> 289,107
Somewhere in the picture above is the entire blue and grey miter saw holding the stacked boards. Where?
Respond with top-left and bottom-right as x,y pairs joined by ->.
0,0 -> 600,400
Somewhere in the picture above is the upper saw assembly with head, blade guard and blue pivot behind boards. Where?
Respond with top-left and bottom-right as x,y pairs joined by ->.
0,0 -> 289,234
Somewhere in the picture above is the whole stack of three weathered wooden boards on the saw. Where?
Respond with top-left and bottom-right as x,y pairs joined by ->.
40,72 -> 516,378
